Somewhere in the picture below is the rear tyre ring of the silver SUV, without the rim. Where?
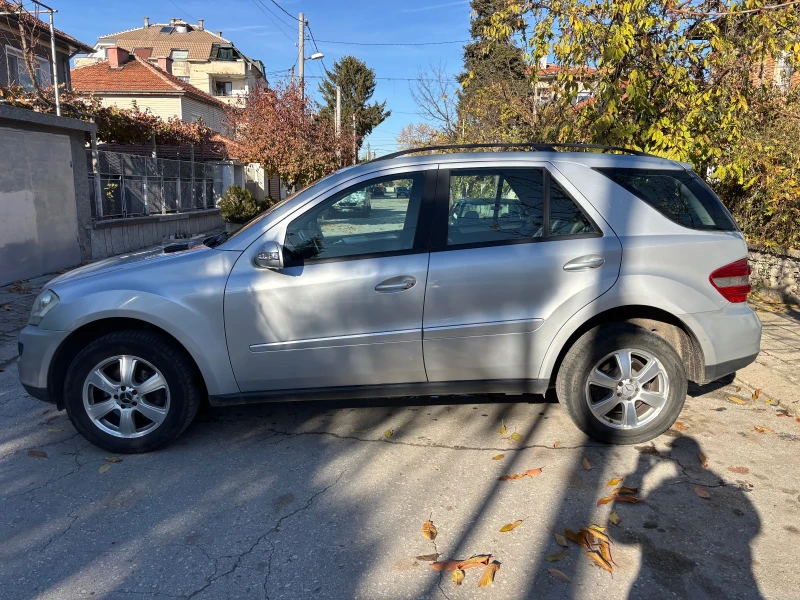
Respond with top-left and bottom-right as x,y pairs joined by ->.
556,323 -> 687,444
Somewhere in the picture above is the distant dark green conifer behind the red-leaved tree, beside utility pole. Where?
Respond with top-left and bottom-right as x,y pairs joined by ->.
319,56 -> 392,148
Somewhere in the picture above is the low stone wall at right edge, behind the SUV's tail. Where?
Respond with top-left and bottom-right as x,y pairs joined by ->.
748,244 -> 800,305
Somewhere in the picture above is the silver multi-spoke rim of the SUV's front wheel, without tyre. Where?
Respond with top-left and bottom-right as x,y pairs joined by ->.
83,354 -> 169,438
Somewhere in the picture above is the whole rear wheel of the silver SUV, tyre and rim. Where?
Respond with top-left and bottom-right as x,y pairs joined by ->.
556,323 -> 687,444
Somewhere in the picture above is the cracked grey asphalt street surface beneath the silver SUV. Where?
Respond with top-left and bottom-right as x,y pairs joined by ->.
0,352 -> 800,600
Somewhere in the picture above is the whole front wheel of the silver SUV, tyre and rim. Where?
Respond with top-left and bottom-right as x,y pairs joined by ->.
64,331 -> 200,453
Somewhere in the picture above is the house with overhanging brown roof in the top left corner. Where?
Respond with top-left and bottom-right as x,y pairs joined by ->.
0,0 -> 94,90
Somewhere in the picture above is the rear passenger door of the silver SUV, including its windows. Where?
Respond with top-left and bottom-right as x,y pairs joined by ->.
423,163 -> 622,381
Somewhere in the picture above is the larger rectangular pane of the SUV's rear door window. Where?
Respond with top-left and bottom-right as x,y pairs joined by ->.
447,169 -> 544,246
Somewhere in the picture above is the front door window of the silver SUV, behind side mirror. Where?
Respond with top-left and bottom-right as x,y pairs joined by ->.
284,173 -> 424,260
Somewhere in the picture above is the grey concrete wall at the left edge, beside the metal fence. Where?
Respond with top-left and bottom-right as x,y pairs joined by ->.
0,105 -> 94,285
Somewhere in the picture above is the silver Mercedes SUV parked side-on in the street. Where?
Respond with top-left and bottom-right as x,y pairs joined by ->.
19,145 -> 761,452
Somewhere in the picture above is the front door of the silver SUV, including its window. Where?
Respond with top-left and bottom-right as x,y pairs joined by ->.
225,168 -> 436,392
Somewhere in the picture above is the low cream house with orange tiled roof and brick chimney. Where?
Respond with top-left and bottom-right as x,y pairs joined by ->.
72,46 -> 228,135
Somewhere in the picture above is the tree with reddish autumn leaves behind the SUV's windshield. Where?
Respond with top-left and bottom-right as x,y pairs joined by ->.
228,83 -> 353,188
